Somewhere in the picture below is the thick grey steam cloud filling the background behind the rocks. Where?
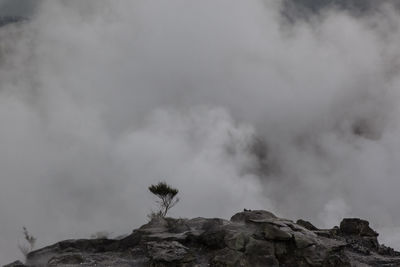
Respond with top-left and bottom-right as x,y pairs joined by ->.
0,0 -> 400,264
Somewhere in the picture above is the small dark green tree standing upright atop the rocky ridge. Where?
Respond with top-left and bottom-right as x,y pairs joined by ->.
149,182 -> 179,217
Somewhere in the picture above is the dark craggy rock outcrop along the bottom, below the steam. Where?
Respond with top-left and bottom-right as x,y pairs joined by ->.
4,210 -> 400,267
